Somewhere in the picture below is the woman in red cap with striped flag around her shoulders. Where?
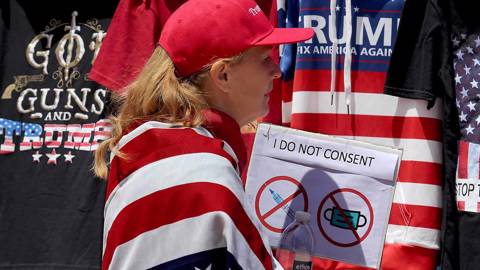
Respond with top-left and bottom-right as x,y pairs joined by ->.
95,0 -> 313,270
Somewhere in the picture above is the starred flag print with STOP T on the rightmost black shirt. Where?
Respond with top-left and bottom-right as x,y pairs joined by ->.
451,34 -> 480,213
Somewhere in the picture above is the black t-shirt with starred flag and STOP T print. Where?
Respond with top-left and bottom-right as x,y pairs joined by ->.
385,0 -> 480,270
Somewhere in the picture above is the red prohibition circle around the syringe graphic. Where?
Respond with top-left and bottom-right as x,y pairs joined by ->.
255,175 -> 308,233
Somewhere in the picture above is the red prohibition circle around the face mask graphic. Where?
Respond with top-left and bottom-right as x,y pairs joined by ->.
317,188 -> 373,247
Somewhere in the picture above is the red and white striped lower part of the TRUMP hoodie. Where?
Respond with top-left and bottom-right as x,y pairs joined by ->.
282,70 -> 442,269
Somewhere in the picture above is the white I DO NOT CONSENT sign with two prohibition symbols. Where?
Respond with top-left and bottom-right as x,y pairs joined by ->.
246,124 -> 402,268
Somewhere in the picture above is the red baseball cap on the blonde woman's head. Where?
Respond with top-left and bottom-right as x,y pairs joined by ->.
158,0 -> 314,77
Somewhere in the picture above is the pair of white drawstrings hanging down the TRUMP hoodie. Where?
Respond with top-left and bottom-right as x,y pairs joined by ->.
328,0 -> 353,114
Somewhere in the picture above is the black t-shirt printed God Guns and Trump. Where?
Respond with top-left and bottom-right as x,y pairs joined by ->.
0,0 -> 117,269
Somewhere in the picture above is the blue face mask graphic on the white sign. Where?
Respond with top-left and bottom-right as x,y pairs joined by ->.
323,206 -> 367,230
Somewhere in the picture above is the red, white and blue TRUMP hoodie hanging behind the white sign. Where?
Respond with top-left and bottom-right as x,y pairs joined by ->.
277,0 -> 442,270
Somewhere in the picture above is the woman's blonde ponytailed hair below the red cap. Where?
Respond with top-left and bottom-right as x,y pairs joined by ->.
93,47 -> 242,179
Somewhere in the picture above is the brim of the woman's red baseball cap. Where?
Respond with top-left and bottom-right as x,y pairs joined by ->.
255,28 -> 314,45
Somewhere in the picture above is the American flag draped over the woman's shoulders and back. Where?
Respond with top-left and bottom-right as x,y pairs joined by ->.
102,121 -> 272,270
